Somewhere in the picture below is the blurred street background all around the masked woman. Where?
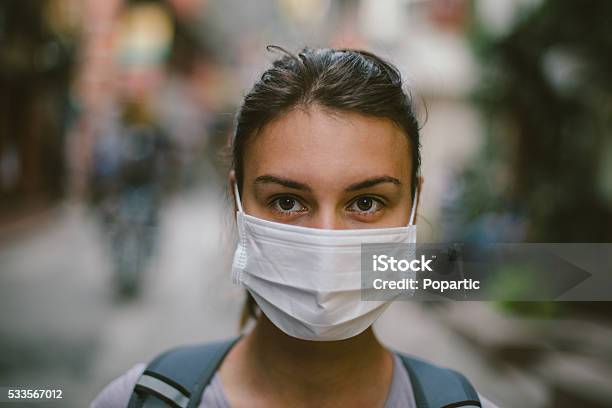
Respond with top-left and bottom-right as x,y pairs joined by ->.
0,0 -> 612,408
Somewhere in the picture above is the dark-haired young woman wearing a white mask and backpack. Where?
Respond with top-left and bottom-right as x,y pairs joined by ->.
92,49 -> 492,408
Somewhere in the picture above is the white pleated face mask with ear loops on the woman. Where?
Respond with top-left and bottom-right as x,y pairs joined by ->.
232,184 -> 417,341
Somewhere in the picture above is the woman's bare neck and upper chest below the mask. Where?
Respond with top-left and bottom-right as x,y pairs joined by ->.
222,315 -> 393,406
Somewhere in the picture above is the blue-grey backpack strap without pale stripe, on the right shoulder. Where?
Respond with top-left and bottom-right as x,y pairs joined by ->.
397,353 -> 481,408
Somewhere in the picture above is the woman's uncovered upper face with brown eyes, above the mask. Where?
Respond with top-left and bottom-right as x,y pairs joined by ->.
241,106 -> 412,229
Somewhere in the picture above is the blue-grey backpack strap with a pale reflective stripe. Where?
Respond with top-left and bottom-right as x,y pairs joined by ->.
128,337 -> 239,408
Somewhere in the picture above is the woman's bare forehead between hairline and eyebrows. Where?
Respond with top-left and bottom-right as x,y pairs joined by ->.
244,107 -> 411,184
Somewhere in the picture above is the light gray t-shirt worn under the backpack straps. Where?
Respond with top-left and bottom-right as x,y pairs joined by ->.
90,354 -> 496,408
